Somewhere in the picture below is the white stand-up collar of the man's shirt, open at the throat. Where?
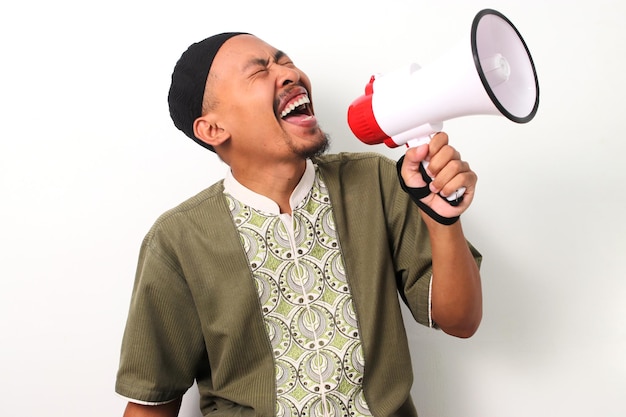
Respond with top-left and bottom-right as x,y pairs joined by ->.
224,159 -> 315,215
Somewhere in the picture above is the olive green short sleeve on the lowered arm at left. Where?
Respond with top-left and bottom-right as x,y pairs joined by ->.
115,236 -> 206,404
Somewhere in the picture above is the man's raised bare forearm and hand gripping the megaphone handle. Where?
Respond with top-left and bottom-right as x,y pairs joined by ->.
401,133 -> 482,337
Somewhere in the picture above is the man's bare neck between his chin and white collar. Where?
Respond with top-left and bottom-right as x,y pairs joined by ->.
230,160 -> 306,214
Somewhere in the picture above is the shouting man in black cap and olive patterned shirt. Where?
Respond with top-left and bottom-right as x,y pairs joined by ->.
116,33 -> 482,417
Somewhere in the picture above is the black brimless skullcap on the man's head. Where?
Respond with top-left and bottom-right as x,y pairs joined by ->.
167,32 -> 246,152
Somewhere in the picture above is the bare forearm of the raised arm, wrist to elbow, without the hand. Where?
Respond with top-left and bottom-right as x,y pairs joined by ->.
424,216 -> 482,337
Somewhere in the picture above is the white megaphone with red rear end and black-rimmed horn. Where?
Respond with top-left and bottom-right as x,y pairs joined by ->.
348,9 -> 539,201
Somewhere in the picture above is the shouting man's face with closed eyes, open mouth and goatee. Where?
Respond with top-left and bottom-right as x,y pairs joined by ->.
207,35 -> 327,158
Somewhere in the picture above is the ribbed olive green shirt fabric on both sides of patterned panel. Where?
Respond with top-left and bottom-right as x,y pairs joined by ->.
116,154 -> 480,417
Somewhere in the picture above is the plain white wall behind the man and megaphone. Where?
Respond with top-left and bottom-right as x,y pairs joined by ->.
0,0 -> 626,417
